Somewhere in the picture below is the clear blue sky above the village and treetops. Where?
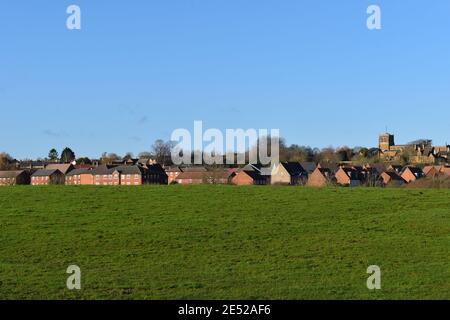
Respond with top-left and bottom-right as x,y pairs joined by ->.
0,0 -> 450,158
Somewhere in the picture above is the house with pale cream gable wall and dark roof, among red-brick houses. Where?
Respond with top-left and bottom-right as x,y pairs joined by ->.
270,162 -> 308,185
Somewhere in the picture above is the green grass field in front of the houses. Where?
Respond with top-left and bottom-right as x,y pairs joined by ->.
0,186 -> 450,299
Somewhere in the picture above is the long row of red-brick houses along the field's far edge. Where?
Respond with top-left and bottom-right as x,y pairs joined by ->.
0,162 -> 450,187
